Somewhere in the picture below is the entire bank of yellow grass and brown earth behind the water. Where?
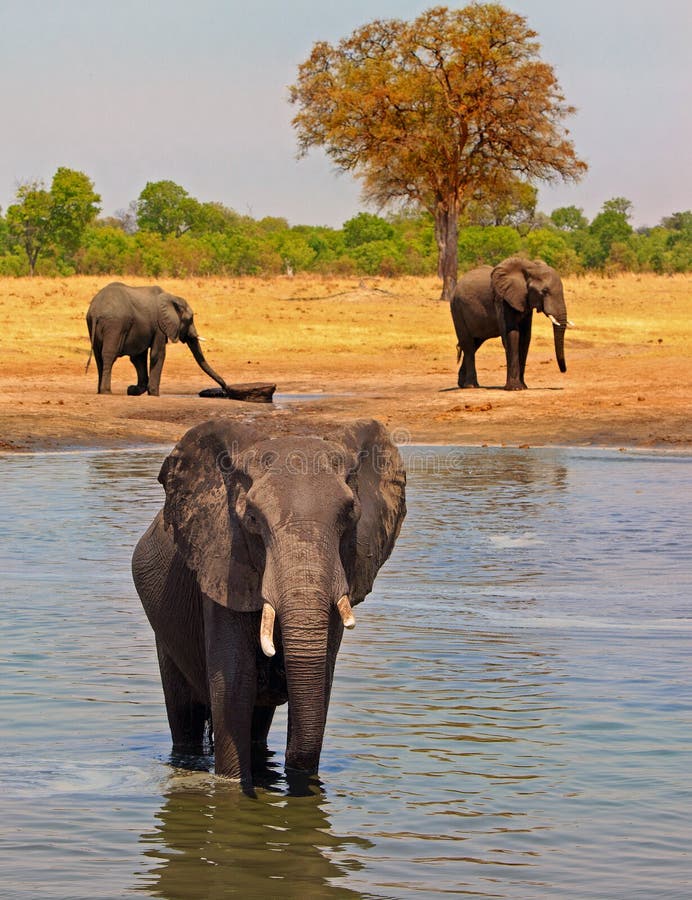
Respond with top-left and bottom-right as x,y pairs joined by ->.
0,274 -> 692,452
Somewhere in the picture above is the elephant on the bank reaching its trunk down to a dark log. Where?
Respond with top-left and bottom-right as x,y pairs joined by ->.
86,281 -> 227,396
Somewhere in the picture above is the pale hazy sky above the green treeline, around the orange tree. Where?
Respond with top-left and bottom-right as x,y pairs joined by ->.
0,0 -> 692,226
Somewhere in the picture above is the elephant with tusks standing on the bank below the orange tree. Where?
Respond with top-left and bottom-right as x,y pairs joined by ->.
451,256 -> 567,391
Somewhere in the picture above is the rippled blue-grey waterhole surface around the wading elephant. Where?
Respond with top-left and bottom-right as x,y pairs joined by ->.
0,448 -> 692,900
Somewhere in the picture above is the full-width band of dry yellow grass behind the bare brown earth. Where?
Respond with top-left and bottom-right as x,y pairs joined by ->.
0,274 -> 692,380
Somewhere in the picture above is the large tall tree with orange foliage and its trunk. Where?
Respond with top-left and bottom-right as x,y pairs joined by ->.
291,3 -> 586,299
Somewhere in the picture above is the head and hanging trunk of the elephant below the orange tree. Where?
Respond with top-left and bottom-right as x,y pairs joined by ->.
490,256 -> 571,372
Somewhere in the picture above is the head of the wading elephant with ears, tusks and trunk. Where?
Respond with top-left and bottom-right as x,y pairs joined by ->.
159,421 -> 405,772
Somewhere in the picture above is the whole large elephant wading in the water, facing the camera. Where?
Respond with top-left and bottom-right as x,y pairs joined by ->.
132,420 -> 406,788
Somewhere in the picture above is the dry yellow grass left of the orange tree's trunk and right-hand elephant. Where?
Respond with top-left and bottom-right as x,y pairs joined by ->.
0,277 -> 449,380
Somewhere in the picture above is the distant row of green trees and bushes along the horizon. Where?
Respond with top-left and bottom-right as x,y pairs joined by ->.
0,169 -> 692,278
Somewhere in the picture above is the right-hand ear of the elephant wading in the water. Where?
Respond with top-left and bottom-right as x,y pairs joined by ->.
333,419 -> 406,605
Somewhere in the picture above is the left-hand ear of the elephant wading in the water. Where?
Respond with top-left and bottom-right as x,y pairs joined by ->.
159,421 -> 262,612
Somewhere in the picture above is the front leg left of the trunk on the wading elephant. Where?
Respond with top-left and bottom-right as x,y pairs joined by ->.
204,598 -> 259,788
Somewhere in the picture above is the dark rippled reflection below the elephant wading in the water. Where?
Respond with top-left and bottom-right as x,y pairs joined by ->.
140,774 -> 373,900
